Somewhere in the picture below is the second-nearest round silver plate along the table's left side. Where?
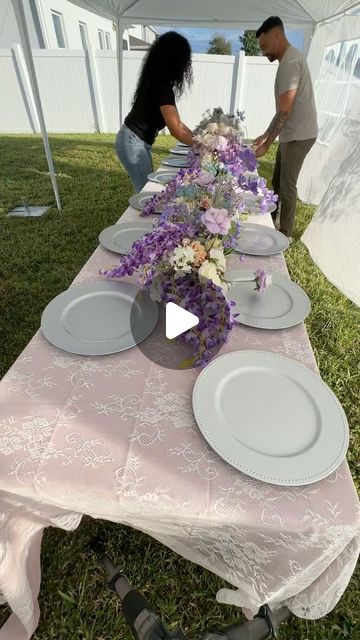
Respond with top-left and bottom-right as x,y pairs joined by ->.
99,220 -> 154,255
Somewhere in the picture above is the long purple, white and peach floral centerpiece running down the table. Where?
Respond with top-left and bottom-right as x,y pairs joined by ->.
101,109 -> 272,366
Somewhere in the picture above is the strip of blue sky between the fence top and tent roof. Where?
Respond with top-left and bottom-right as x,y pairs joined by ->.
157,27 -> 303,54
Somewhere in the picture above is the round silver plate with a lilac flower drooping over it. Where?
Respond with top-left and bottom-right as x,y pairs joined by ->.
225,269 -> 311,329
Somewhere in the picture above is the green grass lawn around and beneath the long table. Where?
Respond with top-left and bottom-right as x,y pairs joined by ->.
0,134 -> 360,640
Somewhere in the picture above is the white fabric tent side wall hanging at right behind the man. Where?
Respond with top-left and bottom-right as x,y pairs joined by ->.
298,15 -> 360,306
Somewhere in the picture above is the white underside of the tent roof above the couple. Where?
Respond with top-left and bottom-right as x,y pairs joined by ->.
70,0 -> 358,30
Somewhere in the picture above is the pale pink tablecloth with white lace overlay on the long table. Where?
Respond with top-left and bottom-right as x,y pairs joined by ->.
0,175 -> 360,640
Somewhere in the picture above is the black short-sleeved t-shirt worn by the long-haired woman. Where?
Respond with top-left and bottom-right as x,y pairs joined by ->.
125,83 -> 175,144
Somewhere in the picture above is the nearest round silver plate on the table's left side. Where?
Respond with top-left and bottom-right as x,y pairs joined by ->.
41,279 -> 159,356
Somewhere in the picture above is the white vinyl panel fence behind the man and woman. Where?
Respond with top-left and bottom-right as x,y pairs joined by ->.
0,45 -> 277,137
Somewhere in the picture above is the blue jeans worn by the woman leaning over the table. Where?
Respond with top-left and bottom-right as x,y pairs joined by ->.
115,124 -> 154,192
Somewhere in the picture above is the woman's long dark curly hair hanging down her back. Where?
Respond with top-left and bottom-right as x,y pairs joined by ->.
133,31 -> 193,102
